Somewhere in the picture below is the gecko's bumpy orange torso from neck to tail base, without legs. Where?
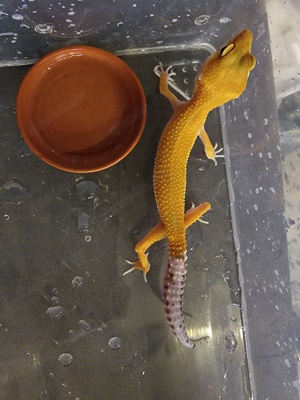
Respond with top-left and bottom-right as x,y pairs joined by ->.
153,98 -> 211,256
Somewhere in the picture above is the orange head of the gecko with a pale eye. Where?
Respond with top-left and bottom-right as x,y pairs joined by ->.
195,30 -> 256,106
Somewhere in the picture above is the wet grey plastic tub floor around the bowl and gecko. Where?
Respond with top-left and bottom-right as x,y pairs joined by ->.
0,49 -> 250,400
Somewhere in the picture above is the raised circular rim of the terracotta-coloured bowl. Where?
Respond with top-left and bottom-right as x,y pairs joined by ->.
16,45 -> 147,173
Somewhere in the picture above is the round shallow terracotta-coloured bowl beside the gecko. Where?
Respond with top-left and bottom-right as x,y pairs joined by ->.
17,46 -> 146,172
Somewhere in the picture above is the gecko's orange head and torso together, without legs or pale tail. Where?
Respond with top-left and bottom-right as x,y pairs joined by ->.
154,30 -> 255,257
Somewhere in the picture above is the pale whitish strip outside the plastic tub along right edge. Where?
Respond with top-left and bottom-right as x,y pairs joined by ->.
265,0 -> 300,391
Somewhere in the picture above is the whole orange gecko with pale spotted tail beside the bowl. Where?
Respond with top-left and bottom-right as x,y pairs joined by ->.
125,30 -> 256,347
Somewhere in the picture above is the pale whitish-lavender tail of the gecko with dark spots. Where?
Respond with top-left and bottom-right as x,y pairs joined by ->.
163,253 -> 195,348
